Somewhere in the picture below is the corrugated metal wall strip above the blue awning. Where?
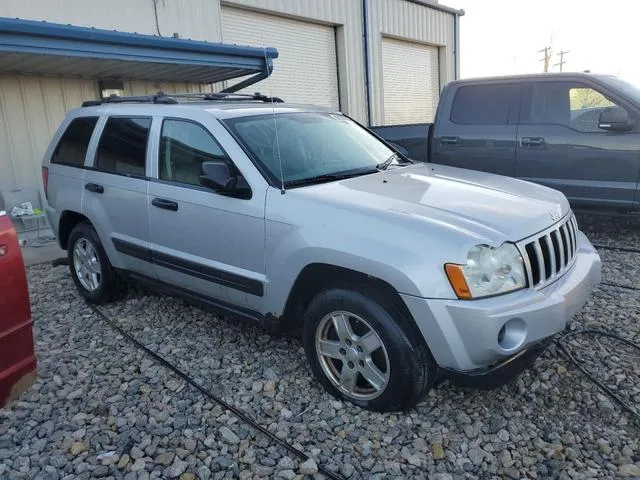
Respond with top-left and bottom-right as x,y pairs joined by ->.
0,0 -> 220,42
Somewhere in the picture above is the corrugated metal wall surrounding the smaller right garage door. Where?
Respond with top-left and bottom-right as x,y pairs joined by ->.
369,0 -> 455,125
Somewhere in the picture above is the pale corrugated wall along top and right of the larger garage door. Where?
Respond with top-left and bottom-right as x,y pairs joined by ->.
222,0 -> 367,123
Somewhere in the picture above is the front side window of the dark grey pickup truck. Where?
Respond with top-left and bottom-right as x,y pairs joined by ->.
530,82 -> 615,132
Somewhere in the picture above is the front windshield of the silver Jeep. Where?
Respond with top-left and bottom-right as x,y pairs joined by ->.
223,112 -> 410,187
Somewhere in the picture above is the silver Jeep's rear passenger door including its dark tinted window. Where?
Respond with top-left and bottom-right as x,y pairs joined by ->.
82,116 -> 155,277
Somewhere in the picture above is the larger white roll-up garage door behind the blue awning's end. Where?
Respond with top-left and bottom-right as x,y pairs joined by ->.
222,7 -> 339,110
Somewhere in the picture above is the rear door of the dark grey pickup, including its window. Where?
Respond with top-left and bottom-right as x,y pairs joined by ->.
431,82 -> 522,176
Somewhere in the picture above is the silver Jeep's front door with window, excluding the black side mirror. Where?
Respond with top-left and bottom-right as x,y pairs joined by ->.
149,118 -> 266,311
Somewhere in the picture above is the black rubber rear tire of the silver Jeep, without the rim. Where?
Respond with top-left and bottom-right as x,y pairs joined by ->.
67,222 -> 116,304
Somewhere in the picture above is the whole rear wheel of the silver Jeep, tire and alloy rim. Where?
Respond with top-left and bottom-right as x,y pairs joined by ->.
67,222 -> 119,304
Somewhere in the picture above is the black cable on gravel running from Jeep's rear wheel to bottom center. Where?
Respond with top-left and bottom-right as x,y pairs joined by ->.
89,305 -> 345,480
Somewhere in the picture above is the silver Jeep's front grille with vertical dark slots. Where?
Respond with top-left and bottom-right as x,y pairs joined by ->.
519,213 -> 578,287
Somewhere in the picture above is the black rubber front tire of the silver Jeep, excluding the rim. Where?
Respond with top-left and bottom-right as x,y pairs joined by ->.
303,288 -> 435,411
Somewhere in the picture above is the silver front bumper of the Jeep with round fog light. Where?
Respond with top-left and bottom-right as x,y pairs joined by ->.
402,232 -> 601,375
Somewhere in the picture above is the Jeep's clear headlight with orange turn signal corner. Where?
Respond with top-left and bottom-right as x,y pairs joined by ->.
445,243 -> 527,300
